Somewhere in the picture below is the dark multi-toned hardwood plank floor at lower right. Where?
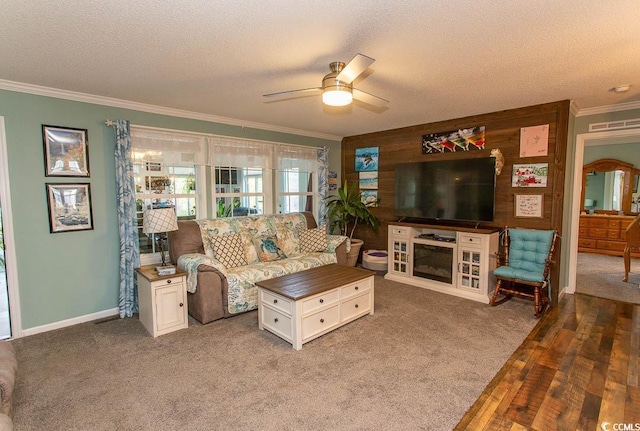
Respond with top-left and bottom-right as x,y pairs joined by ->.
455,294 -> 640,431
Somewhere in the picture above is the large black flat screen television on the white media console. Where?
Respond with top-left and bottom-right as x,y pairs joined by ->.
394,157 -> 496,222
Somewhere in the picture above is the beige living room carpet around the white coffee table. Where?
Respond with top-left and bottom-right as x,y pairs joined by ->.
12,276 -> 537,431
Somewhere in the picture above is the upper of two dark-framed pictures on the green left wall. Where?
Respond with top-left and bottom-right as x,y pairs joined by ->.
42,124 -> 89,177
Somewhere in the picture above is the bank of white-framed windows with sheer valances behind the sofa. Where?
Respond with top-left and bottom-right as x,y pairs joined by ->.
131,126 -> 326,258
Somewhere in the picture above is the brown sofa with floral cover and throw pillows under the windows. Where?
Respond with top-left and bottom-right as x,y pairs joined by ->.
169,212 -> 349,323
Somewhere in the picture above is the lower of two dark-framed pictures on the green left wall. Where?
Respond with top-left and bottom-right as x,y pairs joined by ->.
45,183 -> 93,233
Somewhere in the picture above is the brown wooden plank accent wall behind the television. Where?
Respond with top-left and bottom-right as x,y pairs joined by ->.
342,100 -> 570,305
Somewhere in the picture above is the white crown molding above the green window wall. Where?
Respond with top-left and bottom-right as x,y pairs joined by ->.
0,79 -> 342,141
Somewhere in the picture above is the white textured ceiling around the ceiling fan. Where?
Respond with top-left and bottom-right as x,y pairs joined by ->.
0,0 -> 640,137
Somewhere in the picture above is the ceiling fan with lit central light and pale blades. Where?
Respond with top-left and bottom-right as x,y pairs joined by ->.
263,54 -> 389,108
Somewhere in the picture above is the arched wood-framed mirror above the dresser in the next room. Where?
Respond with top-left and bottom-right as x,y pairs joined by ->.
581,159 -> 640,215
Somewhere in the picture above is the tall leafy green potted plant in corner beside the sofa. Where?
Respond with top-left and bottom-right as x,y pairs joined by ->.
327,180 -> 379,266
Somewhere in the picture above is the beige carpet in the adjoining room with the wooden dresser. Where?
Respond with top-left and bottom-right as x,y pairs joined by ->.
576,253 -> 640,304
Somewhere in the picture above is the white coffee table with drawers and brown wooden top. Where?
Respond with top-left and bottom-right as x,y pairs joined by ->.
256,264 -> 375,350
